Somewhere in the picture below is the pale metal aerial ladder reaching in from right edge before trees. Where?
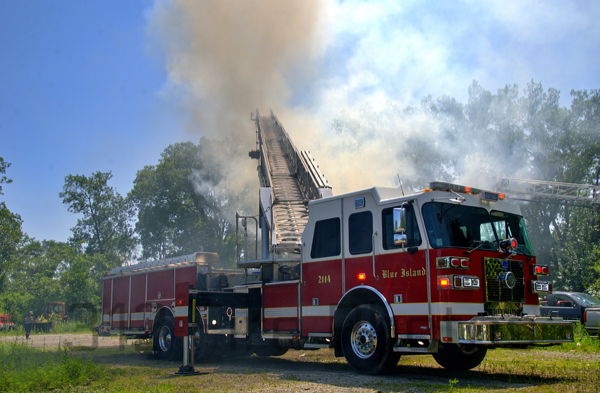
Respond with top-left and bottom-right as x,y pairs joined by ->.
496,177 -> 600,207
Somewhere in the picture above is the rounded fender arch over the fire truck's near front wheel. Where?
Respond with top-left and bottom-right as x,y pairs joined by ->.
333,285 -> 396,338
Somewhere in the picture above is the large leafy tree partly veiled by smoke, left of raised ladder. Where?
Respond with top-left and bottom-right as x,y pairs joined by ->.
129,138 -> 245,266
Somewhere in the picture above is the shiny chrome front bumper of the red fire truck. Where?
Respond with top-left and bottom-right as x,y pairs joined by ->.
440,316 -> 574,346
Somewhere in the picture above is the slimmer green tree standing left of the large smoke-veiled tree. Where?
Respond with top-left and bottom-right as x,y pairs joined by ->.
59,171 -> 136,266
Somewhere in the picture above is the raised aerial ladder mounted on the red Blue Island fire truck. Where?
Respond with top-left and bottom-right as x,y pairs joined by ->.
238,109 -> 333,267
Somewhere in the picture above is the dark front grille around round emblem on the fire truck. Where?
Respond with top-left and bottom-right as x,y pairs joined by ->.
485,258 -> 525,315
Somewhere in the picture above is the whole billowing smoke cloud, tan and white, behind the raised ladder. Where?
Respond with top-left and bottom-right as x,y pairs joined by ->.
149,0 -> 568,202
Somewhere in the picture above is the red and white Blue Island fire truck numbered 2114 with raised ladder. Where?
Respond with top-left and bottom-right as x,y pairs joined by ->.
100,111 -> 573,374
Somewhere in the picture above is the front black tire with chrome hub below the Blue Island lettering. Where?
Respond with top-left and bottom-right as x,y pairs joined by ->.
342,305 -> 400,374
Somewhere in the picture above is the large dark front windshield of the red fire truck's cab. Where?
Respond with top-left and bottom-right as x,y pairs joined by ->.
423,202 -> 533,255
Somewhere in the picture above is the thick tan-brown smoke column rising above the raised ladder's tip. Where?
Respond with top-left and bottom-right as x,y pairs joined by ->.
149,0 -> 323,145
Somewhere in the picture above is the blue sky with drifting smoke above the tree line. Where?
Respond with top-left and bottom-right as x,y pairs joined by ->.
0,0 -> 600,241
